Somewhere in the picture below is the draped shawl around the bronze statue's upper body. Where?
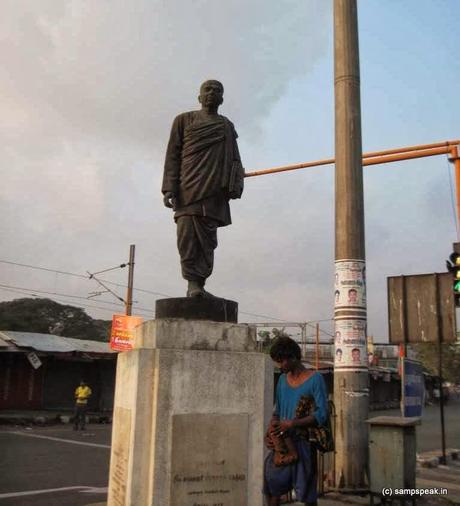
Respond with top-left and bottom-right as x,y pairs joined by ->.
162,111 -> 239,207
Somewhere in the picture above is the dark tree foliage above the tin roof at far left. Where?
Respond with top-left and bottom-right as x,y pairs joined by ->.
0,298 -> 111,341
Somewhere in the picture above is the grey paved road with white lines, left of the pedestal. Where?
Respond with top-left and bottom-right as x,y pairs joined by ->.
0,425 -> 111,506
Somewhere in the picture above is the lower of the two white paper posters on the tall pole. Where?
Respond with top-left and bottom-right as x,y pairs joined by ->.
334,318 -> 368,370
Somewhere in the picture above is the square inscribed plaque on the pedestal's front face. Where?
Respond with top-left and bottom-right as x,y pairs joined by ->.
171,414 -> 249,506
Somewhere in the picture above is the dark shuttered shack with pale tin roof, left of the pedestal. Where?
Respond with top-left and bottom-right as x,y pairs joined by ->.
0,331 -> 117,411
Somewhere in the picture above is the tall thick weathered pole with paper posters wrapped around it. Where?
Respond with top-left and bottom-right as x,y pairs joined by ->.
334,0 -> 369,491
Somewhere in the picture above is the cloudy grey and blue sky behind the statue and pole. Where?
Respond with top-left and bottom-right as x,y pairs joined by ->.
0,0 -> 460,341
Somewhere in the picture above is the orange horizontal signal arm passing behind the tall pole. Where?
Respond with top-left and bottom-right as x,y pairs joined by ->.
245,140 -> 460,177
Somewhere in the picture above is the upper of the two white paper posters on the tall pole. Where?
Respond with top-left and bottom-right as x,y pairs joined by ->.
334,260 -> 366,310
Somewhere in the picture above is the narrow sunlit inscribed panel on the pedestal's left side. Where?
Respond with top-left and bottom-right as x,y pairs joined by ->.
109,407 -> 131,506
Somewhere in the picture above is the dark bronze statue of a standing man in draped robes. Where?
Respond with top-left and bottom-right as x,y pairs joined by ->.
161,80 -> 244,297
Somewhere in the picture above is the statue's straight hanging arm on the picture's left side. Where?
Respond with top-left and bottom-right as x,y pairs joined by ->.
161,115 -> 184,207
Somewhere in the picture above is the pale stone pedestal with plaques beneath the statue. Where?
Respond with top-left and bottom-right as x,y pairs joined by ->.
108,319 -> 273,506
